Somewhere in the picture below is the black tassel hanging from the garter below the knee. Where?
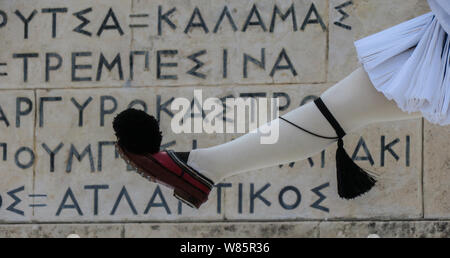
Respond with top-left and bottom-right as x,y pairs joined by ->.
336,138 -> 376,199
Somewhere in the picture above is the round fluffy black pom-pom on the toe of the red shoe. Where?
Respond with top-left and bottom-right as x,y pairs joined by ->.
113,108 -> 162,155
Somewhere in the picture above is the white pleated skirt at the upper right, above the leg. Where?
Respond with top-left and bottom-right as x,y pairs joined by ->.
355,13 -> 450,125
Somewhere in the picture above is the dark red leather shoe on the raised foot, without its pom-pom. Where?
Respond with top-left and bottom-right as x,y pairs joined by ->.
116,143 -> 214,209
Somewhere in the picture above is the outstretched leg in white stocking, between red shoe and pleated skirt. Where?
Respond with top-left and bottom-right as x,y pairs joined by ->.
188,68 -> 421,183
